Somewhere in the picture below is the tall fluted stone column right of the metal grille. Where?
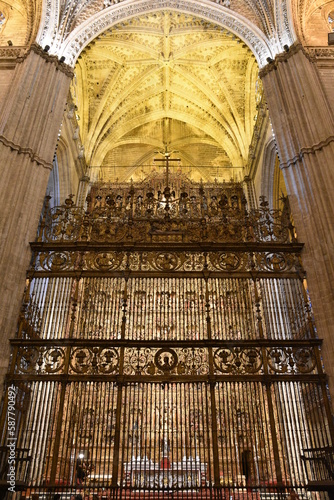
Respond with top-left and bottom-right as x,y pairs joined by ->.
261,45 -> 334,397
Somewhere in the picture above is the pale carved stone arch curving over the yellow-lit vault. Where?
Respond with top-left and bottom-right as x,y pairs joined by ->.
37,0 -> 288,67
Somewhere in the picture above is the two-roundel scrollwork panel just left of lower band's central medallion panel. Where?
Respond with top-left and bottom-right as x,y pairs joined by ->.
70,346 -> 119,374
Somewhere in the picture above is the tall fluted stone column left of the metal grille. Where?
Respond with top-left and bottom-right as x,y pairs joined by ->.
0,45 -> 73,392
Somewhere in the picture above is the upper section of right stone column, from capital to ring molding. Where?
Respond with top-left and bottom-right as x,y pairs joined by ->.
261,44 -> 334,168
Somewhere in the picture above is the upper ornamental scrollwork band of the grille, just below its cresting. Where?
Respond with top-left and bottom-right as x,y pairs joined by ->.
32,248 -> 303,276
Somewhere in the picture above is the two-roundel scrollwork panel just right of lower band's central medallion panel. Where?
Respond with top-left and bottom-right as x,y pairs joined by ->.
213,347 -> 263,374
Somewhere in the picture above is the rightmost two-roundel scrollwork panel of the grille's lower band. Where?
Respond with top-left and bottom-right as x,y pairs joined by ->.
267,347 -> 316,374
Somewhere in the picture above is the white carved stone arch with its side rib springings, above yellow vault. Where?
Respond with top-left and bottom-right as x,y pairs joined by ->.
37,0 -> 295,66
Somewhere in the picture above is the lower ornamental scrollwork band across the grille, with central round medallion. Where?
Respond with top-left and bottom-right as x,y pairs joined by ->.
14,344 -> 318,378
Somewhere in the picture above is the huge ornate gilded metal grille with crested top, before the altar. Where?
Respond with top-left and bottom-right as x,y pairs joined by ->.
0,176 -> 334,499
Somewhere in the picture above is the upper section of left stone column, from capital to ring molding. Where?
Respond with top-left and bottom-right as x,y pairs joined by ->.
0,44 -> 72,165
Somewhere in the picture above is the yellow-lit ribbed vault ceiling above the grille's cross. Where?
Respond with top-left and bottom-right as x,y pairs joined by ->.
72,11 -> 261,180
